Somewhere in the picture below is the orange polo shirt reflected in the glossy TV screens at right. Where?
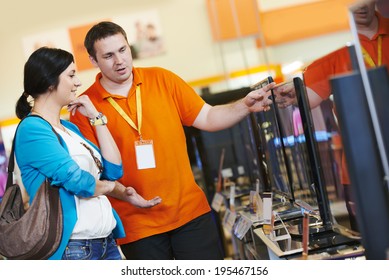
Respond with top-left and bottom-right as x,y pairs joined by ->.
304,12 -> 389,184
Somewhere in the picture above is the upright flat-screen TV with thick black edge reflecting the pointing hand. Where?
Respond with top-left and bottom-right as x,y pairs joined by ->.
272,77 -> 334,228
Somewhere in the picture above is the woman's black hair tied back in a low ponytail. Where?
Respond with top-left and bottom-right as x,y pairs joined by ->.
16,47 -> 74,119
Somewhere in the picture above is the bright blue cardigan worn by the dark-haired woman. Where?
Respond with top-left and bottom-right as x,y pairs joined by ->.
15,117 -> 125,260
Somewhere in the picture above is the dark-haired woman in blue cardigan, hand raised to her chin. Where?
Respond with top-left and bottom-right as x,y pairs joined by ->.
15,47 -> 160,259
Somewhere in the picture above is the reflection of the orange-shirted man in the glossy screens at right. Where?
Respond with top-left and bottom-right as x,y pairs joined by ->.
276,0 -> 389,230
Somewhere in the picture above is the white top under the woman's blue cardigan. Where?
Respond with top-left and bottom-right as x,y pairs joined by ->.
55,127 -> 116,239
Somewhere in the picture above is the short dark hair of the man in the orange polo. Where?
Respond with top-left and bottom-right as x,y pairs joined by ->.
84,21 -> 128,60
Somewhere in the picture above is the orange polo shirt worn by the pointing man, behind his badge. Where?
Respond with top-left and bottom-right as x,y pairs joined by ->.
70,67 -> 210,244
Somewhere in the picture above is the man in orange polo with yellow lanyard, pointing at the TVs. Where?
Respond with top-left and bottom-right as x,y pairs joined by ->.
71,22 -> 274,259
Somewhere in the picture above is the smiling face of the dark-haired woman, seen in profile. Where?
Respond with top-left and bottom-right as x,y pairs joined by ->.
57,62 -> 81,106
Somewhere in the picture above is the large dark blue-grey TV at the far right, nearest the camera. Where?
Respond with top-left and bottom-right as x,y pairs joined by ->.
331,67 -> 389,260
